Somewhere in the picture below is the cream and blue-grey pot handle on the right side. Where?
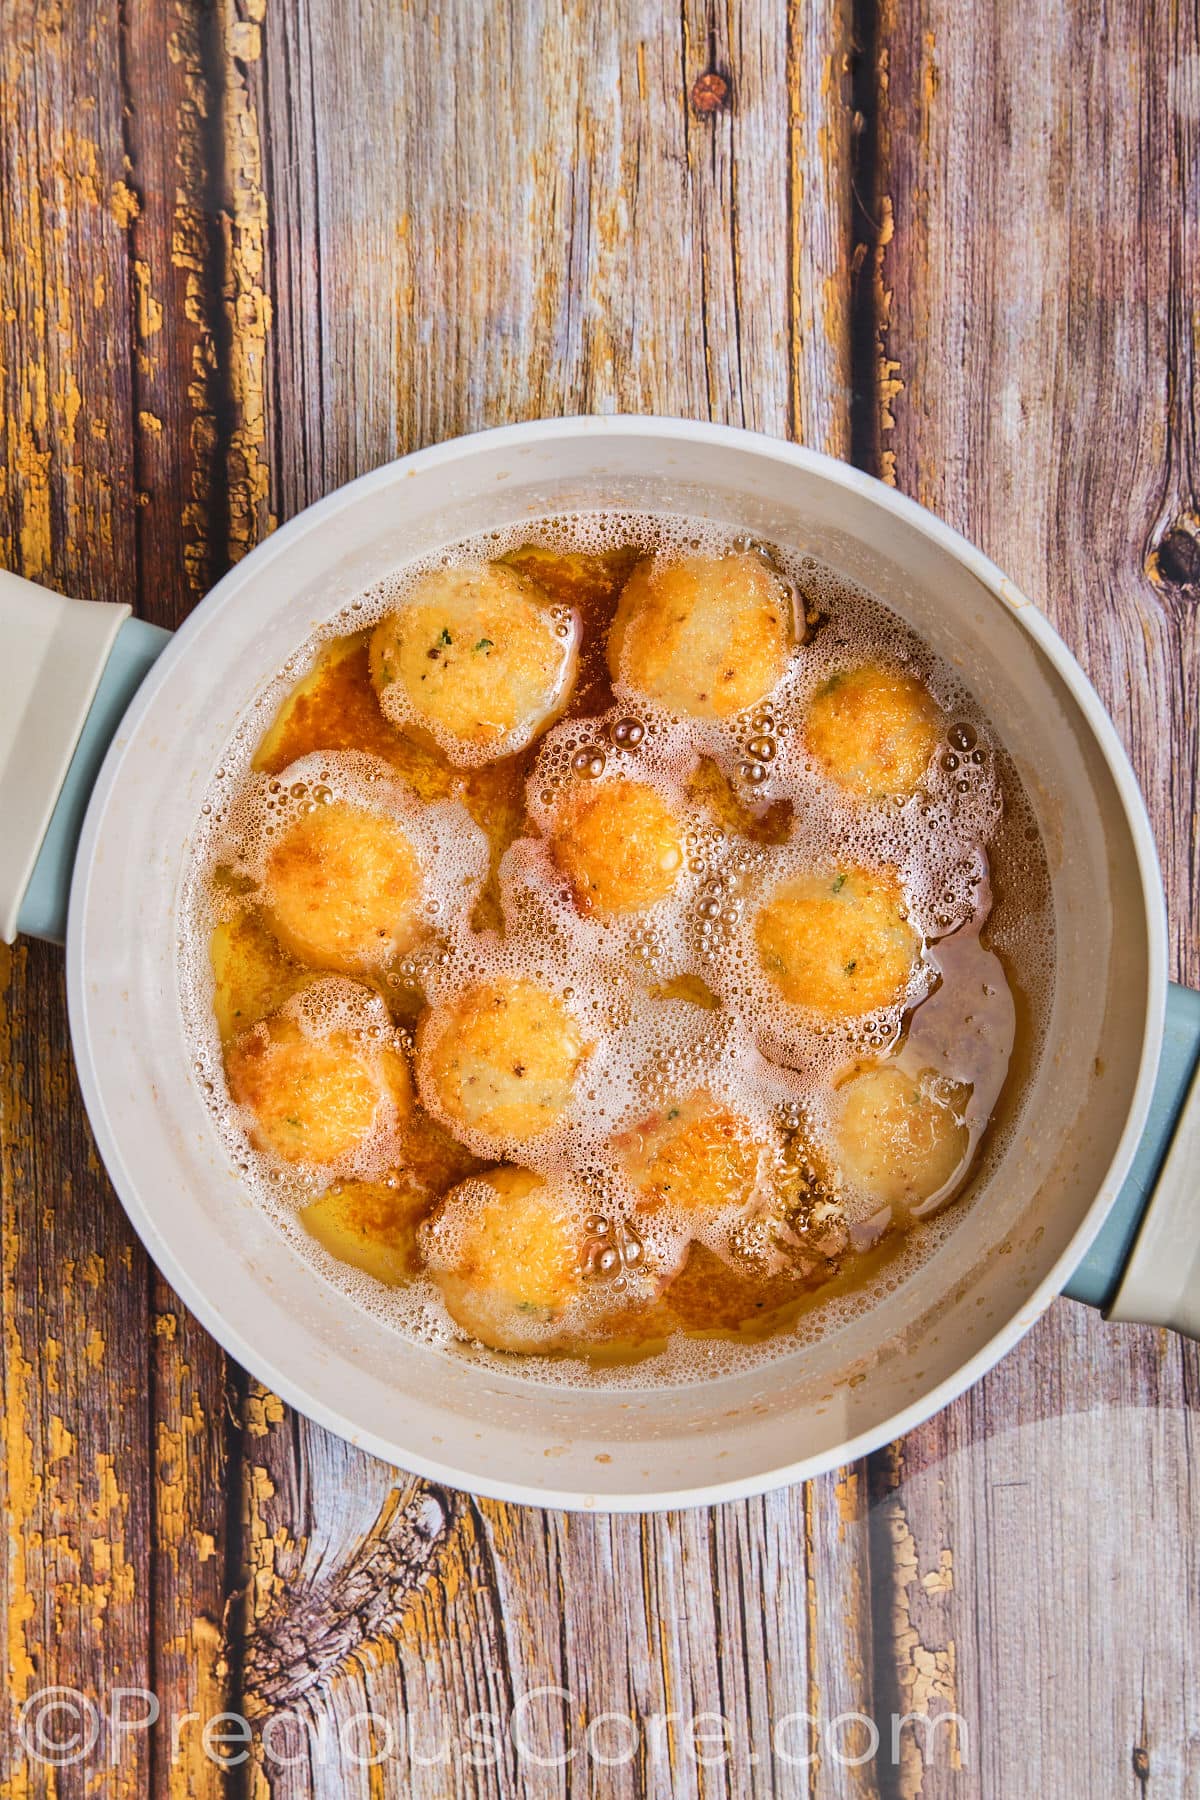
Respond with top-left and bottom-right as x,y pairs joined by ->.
1065,985 -> 1200,1337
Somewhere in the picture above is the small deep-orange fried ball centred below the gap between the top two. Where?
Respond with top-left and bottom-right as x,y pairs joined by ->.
551,779 -> 684,914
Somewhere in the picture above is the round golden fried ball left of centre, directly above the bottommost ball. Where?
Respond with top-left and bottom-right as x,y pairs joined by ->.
417,977 -> 590,1139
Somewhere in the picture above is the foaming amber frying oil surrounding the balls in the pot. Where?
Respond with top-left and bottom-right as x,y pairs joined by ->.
180,513 -> 1054,1386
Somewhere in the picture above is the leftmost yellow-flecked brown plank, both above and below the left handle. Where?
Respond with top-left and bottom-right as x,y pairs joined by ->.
0,4 -> 151,1795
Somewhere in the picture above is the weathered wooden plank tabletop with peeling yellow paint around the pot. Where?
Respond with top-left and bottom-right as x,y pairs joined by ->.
0,0 -> 1200,1800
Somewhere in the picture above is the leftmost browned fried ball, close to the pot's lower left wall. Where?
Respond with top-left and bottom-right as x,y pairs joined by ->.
225,1013 -> 412,1165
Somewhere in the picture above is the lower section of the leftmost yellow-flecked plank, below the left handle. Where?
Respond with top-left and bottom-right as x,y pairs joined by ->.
0,945 -> 151,1795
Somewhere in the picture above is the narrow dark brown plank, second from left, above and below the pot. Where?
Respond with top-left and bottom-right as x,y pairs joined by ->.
119,14 -> 244,1796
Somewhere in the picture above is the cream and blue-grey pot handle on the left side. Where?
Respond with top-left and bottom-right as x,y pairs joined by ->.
0,569 -> 171,943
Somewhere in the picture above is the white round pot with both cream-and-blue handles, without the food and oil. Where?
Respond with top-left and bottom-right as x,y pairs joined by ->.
0,418 -> 1200,1508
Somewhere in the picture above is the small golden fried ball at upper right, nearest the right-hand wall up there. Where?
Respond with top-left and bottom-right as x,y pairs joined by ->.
804,662 -> 945,799
